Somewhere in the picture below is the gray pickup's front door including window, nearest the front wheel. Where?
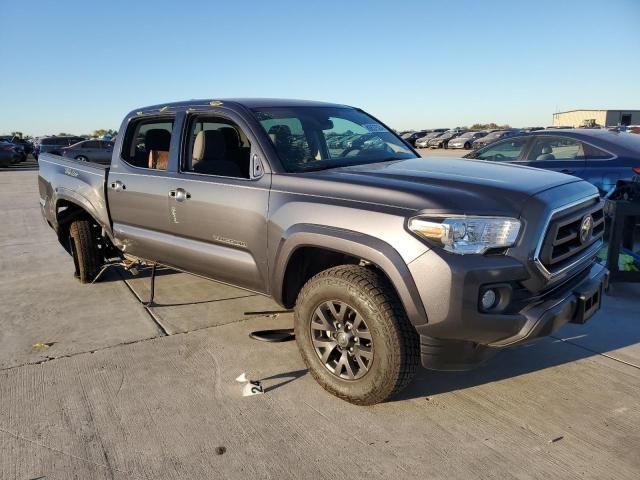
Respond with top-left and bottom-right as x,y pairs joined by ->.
165,109 -> 271,292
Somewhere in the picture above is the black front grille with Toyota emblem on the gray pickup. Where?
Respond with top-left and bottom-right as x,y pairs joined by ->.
539,198 -> 604,274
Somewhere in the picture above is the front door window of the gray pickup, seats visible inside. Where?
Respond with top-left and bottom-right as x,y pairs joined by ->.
181,117 -> 251,179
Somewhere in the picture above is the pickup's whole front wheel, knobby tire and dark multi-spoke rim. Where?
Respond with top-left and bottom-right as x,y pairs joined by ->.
294,265 -> 420,405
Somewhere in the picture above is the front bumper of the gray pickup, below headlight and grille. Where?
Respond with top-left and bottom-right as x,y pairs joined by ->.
409,250 -> 609,348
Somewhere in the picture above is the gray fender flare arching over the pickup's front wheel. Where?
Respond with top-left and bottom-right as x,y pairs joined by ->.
271,224 -> 428,326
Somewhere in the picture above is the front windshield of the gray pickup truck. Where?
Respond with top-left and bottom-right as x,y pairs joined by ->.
253,107 -> 417,172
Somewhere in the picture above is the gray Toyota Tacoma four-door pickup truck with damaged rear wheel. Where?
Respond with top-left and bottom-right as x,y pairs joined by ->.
39,99 -> 608,405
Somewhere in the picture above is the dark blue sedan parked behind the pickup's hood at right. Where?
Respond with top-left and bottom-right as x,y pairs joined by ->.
465,129 -> 640,195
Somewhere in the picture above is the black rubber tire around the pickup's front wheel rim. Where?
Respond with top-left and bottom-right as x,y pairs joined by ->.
294,265 -> 420,405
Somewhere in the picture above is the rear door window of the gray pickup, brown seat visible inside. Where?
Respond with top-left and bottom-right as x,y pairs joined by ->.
122,117 -> 174,170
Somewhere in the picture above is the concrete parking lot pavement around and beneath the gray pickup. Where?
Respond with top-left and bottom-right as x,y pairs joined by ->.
0,156 -> 640,480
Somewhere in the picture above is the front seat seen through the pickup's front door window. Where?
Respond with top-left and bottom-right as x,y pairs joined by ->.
191,130 -> 243,178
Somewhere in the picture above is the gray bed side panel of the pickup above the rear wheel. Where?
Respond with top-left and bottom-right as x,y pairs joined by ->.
38,153 -> 111,233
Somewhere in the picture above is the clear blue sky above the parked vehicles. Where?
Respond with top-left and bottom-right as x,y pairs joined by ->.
0,0 -> 640,135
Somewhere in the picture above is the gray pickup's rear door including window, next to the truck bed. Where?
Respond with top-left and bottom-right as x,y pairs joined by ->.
107,114 -> 179,265
